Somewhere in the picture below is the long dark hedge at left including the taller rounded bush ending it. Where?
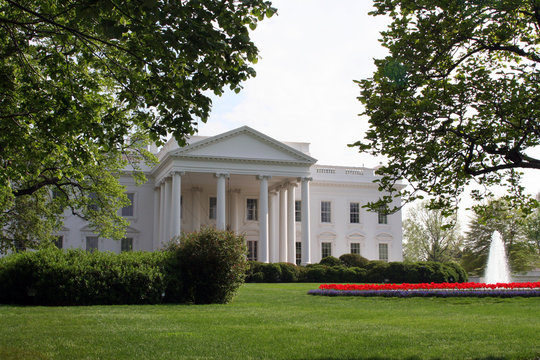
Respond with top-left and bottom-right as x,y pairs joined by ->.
0,229 -> 247,305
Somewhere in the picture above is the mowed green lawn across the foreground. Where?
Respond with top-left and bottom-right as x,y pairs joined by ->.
0,284 -> 540,360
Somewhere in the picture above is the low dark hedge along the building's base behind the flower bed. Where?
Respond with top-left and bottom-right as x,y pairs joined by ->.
246,258 -> 468,283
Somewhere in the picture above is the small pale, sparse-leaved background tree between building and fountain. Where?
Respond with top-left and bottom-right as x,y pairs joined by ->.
403,201 -> 463,262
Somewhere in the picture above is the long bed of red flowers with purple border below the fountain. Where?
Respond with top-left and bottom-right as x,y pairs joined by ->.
308,282 -> 540,297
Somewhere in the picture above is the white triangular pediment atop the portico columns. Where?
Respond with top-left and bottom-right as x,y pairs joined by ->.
171,126 -> 317,165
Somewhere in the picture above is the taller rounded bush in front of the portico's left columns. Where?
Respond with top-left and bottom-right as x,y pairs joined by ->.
168,228 -> 247,304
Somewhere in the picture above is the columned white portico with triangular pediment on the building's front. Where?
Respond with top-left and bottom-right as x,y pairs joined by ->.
151,126 -> 316,264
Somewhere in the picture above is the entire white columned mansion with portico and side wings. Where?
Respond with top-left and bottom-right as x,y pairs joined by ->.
59,126 -> 402,264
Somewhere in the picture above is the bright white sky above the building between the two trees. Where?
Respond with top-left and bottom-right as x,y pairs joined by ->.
198,0 -> 540,221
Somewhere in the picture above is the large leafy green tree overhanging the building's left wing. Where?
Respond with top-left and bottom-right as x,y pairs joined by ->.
0,0 -> 275,253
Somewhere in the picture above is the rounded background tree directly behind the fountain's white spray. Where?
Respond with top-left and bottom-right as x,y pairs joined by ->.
462,198 -> 538,275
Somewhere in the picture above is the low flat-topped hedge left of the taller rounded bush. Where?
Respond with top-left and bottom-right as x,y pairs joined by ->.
0,248 -> 165,305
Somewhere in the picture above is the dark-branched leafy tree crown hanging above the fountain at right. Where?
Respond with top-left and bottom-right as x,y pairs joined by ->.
351,0 -> 540,214
